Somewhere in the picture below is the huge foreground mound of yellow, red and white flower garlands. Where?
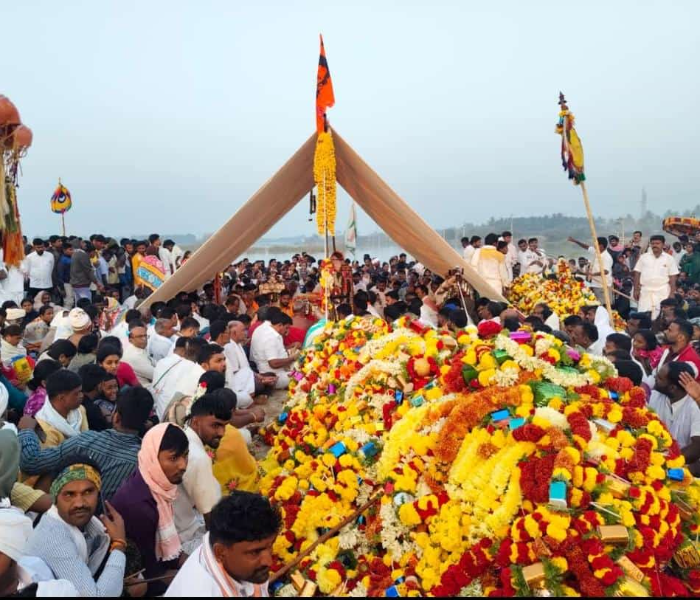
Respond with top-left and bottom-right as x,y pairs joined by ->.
261,319 -> 700,597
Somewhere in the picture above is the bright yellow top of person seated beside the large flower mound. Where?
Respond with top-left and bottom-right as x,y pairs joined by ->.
213,425 -> 260,496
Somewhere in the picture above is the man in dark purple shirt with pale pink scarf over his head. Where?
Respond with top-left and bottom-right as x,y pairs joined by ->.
112,423 -> 189,596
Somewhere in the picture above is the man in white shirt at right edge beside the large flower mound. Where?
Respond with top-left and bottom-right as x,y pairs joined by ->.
648,362 -> 700,466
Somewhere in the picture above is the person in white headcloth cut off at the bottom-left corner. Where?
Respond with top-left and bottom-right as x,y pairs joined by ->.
0,508 -> 78,598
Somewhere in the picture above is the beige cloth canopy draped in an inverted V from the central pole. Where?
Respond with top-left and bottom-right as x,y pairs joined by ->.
141,130 -> 505,310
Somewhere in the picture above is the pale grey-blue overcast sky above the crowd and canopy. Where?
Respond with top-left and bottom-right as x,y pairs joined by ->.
0,0 -> 700,236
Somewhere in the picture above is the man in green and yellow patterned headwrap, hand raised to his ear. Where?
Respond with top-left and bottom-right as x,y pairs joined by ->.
27,458 -> 126,597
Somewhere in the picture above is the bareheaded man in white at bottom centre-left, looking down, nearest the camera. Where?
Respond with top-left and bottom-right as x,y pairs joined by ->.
165,492 -> 282,598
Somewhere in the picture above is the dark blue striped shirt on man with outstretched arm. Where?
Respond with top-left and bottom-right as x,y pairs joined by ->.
19,429 -> 141,500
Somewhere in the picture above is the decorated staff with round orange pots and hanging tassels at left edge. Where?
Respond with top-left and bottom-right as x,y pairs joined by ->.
0,95 -> 33,267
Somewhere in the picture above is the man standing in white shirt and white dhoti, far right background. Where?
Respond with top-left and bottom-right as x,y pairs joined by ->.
634,235 -> 678,319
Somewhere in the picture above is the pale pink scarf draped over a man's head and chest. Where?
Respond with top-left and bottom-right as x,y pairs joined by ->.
139,423 -> 182,562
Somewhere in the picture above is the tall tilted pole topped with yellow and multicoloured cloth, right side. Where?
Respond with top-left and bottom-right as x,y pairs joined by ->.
556,92 -> 614,324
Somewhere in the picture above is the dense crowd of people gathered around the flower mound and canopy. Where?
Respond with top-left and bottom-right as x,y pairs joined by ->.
0,227 -> 700,597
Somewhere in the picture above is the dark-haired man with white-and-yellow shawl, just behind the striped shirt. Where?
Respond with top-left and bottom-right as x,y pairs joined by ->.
23,369 -> 89,491
